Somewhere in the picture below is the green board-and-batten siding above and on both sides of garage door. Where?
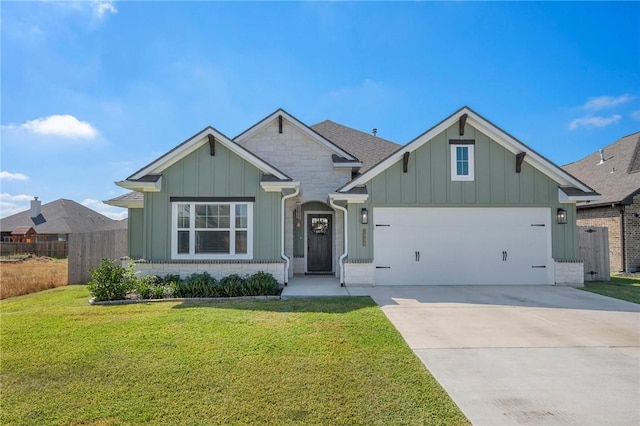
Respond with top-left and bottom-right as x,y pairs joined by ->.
349,124 -> 578,259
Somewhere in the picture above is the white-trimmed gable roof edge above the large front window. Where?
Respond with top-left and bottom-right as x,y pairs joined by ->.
116,126 -> 291,191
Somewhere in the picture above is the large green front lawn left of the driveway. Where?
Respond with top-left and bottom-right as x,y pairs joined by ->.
0,286 -> 468,425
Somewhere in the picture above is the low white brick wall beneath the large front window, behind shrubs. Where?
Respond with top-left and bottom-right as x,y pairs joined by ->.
122,258 -> 284,284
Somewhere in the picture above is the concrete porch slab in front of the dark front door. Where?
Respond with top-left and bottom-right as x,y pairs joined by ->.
281,275 -> 369,299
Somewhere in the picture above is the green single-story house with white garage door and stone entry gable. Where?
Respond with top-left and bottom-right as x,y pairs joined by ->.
107,107 -> 598,285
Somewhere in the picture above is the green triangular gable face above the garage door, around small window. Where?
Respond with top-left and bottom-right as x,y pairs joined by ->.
366,123 -> 558,206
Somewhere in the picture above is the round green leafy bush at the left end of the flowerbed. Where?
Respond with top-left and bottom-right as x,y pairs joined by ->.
87,259 -> 136,302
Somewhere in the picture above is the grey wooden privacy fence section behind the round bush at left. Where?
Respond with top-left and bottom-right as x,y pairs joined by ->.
69,229 -> 127,284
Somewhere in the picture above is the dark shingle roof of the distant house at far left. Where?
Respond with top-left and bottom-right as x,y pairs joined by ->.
0,198 -> 113,234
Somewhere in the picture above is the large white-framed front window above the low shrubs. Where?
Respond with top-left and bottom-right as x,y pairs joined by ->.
171,202 -> 253,259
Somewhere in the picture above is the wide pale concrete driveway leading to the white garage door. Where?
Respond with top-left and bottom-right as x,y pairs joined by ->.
371,286 -> 640,425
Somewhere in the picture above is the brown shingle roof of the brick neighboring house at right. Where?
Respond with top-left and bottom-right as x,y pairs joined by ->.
563,132 -> 640,207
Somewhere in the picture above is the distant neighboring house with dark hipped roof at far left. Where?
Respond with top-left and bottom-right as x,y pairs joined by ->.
0,197 -> 114,241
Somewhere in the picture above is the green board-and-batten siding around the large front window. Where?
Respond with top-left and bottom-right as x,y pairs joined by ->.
139,142 -> 281,260
